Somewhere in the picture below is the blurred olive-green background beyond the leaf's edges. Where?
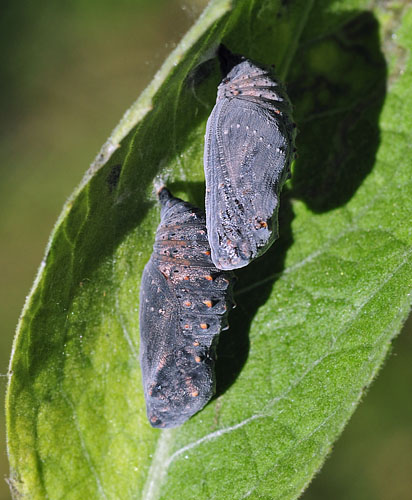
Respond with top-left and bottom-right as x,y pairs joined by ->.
0,0 -> 412,500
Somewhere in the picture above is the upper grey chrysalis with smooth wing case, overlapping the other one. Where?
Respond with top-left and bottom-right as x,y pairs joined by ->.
204,46 -> 296,269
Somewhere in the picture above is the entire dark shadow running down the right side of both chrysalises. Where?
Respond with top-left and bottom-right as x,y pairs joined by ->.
216,8 -> 387,396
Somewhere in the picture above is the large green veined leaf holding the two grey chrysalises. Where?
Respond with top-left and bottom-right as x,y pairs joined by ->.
7,0 -> 412,500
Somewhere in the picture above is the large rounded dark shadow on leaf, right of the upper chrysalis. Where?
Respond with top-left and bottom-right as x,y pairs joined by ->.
288,12 -> 387,213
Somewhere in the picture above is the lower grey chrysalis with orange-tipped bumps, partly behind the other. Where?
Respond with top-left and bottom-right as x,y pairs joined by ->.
140,188 -> 234,427
